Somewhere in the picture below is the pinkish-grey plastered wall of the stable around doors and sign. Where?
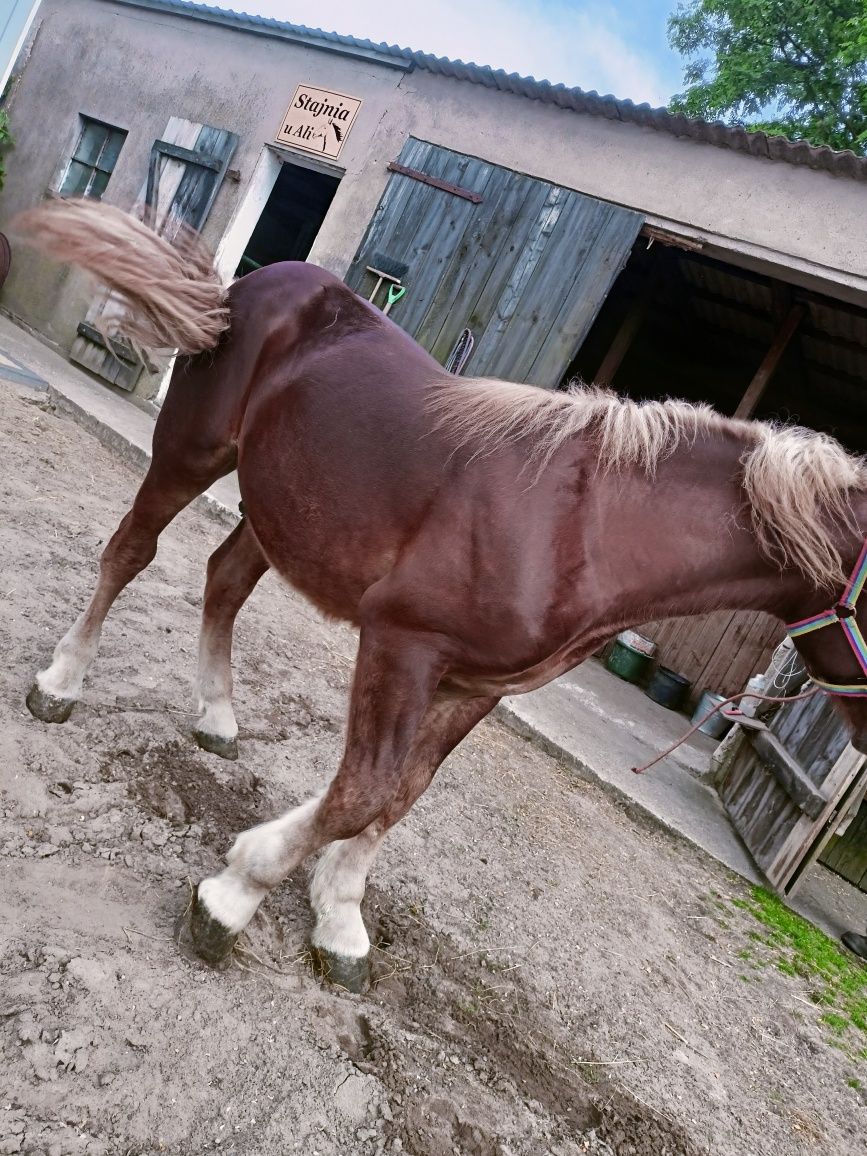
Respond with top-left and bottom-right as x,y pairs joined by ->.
0,0 -> 867,374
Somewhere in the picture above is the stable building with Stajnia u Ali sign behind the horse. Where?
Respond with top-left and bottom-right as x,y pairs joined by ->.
0,0 -> 867,712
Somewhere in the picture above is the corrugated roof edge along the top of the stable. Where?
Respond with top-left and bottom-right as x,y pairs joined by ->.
112,0 -> 867,180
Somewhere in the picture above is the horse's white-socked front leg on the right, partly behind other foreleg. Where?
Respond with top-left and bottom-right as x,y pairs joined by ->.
310,697 -> 498,992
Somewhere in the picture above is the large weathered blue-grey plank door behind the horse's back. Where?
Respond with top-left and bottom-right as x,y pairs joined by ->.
347,140 -> 644,387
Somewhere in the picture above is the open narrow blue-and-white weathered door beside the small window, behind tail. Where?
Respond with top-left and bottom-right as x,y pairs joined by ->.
69,117 -> 238,390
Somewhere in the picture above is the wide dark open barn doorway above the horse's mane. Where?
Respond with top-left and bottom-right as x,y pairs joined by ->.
566,236 -> 867,453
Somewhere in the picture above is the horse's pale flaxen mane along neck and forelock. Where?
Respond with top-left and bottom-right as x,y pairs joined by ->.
429,378 -> 867,587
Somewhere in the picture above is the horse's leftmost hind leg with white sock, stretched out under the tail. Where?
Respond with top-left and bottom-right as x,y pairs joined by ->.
27,455 -> 232,723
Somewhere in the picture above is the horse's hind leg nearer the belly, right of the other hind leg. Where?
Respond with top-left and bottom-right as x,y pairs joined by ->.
193,518 -> 268,758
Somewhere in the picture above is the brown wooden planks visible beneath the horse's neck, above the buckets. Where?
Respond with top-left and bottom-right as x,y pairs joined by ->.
637,610 -> 785,701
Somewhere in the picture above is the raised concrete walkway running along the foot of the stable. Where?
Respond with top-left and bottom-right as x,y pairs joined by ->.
0,316 -> 867,938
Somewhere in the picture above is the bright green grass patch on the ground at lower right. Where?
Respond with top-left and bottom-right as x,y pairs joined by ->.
732,887 -> 867,1059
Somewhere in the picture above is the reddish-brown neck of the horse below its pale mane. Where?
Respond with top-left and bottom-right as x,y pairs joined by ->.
594,432 -> 808,621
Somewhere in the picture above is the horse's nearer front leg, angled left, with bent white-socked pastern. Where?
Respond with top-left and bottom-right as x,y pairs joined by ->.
191,627 -> 443,965
